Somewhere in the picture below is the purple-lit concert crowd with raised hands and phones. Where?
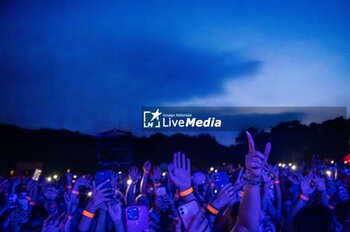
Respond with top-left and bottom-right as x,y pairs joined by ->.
0,132 -> 350,232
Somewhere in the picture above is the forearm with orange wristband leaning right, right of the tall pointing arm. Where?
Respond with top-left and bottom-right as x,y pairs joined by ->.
283,174 -> 316,232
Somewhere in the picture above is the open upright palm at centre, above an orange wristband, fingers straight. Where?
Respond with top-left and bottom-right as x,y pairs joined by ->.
168,152 -> 191,191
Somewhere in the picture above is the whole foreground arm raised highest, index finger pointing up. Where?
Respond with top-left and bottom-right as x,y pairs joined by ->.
233,132 -> 271,232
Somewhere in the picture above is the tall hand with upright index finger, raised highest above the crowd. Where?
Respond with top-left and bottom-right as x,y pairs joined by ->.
245,131 -> 271,180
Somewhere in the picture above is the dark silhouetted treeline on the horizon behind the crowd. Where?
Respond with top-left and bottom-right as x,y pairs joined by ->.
0,118 -> 350,172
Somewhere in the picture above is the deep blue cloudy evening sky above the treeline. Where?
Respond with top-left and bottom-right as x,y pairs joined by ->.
0,0 -> 350,144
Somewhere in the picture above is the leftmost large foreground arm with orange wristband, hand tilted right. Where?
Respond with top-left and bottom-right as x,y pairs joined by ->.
78,180 -> 113,231
